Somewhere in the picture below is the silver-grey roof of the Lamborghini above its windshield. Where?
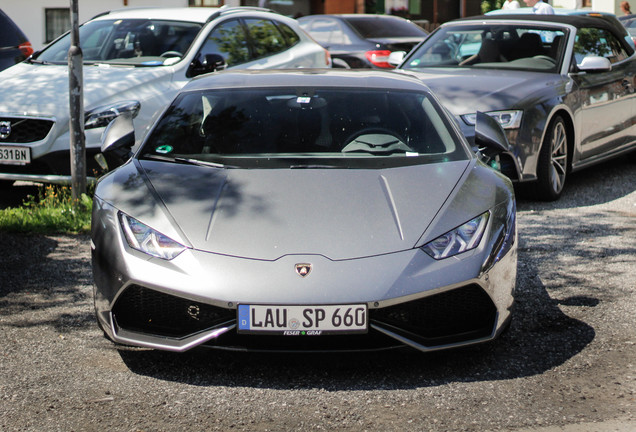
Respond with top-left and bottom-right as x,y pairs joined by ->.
183,69 -> 431,93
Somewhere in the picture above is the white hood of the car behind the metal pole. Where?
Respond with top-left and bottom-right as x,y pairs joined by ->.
0,63 -> 171,119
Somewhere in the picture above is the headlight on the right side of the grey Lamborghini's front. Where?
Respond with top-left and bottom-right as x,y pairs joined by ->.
421,212 -> 490,260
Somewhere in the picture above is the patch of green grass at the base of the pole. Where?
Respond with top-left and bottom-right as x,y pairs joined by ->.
0,185 -> 93,234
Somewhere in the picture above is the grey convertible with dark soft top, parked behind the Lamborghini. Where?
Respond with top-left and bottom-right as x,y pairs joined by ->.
391,13 -> 636,200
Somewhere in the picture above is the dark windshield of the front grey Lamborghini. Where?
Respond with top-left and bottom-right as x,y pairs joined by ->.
139,88 -> 469,168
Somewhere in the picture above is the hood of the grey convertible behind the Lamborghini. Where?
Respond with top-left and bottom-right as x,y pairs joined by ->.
403,68 -> 563,116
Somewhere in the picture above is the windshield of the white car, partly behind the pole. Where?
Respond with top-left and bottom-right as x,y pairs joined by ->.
37,19 -> 201,66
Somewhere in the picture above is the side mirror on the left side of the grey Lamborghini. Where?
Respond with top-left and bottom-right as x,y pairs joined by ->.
101,112 -> 135,168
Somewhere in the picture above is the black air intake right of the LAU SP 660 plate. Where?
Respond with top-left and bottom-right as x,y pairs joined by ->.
369,285 -> 497,346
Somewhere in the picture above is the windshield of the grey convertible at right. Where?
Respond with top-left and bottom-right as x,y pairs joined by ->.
402,23 -> 567,72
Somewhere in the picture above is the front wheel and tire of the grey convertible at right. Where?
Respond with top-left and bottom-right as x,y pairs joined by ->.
535,116 -> 569,201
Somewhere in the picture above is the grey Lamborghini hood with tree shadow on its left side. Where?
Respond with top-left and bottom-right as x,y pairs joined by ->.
103,161 -> 470,260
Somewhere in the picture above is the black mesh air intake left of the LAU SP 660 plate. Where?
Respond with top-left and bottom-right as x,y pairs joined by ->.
113,285 -> 236,338
